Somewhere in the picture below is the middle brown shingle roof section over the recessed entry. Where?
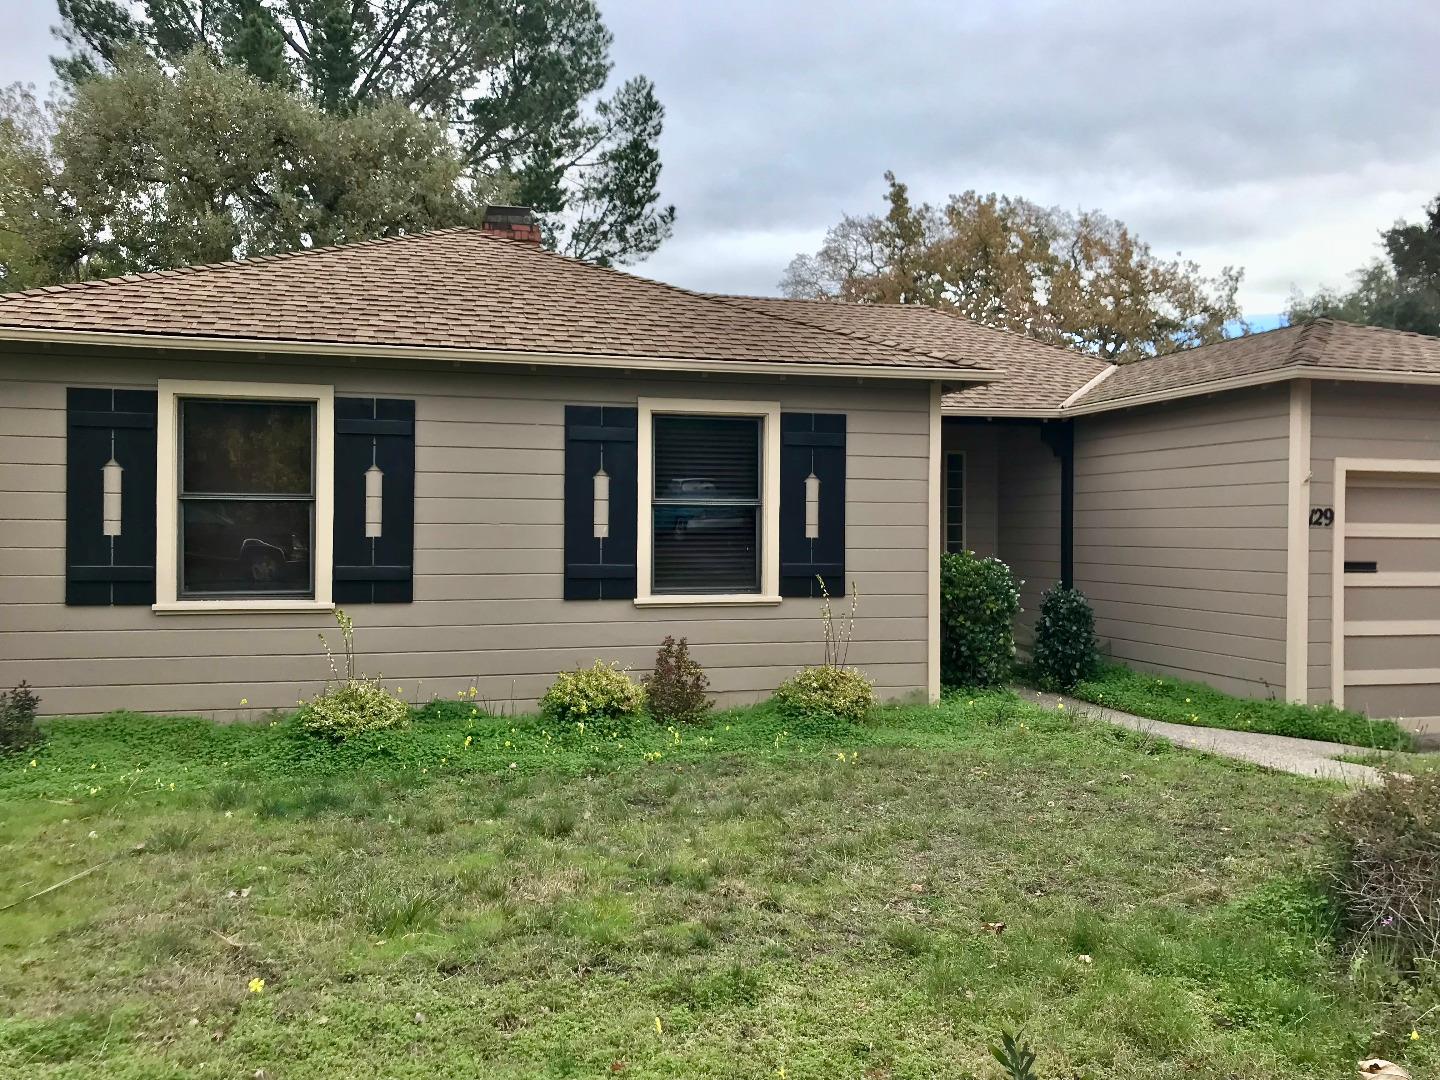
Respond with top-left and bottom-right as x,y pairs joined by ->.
716,295 -> 1106,413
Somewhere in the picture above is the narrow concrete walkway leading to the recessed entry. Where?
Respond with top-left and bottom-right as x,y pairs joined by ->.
1015,687 -> 1384,786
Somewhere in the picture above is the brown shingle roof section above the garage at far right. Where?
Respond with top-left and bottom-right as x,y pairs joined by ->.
1074,318 -> 1440,409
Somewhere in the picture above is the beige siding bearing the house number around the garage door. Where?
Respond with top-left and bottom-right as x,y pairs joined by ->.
1309,382 -> 1440,711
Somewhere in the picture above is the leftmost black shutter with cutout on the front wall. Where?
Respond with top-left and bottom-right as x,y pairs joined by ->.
65,387 -> 157,606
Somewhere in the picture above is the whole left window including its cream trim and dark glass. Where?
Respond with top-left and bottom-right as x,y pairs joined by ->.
156,380 -> 334,611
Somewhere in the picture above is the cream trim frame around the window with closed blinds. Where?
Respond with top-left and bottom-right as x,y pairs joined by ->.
635,397 -> 780,608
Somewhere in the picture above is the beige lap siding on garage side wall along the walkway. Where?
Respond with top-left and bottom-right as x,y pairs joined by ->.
1074,390 -> 1289,697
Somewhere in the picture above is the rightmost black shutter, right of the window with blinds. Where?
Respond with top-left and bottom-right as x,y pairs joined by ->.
780,412 -> 845,596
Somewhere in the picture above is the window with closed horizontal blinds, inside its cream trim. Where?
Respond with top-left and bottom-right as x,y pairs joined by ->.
651,415 -> 762,595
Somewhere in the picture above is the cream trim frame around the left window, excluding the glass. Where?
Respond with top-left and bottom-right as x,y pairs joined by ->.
151,379 -> 336,615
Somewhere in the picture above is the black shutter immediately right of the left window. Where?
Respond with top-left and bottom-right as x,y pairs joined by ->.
333,397 -> 415,603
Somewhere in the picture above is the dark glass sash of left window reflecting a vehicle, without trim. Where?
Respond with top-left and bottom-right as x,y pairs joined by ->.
179,397 -> 315,598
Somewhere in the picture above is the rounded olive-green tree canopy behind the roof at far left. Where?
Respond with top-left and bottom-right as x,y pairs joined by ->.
0,50 -> 495,291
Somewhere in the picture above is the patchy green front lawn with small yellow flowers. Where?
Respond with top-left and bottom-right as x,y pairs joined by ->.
0,694 -> 1440,1080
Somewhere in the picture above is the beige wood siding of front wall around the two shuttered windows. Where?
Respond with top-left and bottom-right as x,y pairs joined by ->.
0,353 -> 930,716
